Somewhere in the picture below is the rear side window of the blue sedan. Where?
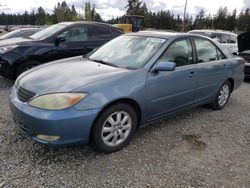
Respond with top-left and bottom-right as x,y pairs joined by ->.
194,39 -> 225,63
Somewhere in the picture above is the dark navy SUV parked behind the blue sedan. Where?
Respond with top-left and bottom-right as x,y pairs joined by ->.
0,22 -> 123,79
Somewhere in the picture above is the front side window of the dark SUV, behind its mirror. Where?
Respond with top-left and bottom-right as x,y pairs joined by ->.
61,26 -> 88,41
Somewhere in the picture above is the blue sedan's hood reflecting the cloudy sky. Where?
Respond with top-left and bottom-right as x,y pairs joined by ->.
16,57 -> 129,95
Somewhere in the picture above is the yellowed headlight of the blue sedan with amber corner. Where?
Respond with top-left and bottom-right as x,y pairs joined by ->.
29,93 -> 88,110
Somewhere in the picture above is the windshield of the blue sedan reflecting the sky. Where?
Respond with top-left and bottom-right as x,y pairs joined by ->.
89,36 -> 166,69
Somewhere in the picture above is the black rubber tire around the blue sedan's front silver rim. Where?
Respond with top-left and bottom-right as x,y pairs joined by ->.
91,103 -> 137,153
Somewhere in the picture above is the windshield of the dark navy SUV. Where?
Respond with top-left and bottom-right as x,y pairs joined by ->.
30,24 -> 66,40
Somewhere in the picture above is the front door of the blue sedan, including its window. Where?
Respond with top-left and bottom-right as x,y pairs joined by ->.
147,38 -> 197,119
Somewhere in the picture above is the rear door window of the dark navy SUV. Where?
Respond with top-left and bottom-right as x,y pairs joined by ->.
91,26 -> 111,40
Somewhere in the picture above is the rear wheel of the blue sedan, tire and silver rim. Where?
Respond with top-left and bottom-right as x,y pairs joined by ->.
211,81 -> 232,110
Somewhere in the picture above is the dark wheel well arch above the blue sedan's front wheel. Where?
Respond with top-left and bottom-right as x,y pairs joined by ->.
90,98 -> 142,138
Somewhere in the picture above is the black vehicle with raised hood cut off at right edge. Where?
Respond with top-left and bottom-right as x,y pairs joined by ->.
238,32 -> 250,79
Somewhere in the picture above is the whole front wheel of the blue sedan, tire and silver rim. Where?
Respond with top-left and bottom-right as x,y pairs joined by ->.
91,103 -> 137,153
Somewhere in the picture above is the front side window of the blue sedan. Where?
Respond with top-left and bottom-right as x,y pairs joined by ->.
159,40 -> 193,67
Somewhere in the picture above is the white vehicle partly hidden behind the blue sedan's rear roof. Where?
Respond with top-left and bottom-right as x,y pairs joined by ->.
188,30 -> 238,53
